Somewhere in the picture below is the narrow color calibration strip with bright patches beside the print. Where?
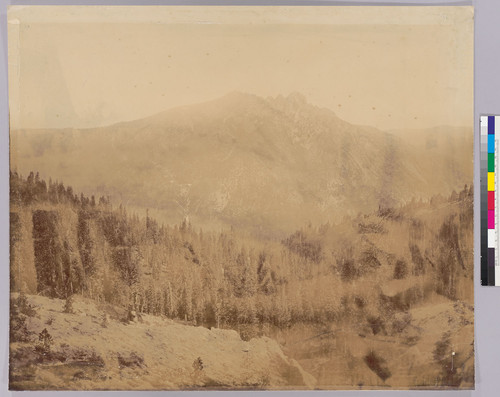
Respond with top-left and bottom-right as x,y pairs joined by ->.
480,116 -> 500,285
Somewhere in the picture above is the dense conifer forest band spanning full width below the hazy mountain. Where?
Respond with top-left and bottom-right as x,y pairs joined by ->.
10,173 -> 472,327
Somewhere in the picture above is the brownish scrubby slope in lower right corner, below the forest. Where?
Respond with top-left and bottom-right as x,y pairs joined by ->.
276,296 -> 474,390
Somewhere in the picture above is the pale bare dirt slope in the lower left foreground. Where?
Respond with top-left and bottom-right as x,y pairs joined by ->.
10,294 -> 315,390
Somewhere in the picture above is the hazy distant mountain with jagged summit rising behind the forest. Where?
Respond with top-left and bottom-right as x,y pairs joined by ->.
11,92 -> 473,237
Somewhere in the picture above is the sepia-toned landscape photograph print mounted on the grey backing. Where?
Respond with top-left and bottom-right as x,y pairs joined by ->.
8,6 -> 475,390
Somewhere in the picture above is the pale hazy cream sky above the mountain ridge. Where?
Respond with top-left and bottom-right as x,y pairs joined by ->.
9,7 -> 473,129
